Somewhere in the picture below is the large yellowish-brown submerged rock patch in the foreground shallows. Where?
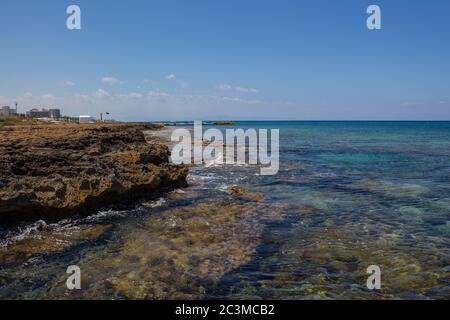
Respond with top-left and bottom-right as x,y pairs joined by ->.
72,201 -> 264,299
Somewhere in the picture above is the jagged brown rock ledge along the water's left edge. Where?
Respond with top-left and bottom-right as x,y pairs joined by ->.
0,123 -> 188,225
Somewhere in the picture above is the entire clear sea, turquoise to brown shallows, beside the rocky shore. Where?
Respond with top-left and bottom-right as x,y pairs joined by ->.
0,122 -> 450,299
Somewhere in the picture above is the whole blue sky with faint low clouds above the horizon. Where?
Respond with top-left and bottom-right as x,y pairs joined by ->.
0,0 -> 450,120
